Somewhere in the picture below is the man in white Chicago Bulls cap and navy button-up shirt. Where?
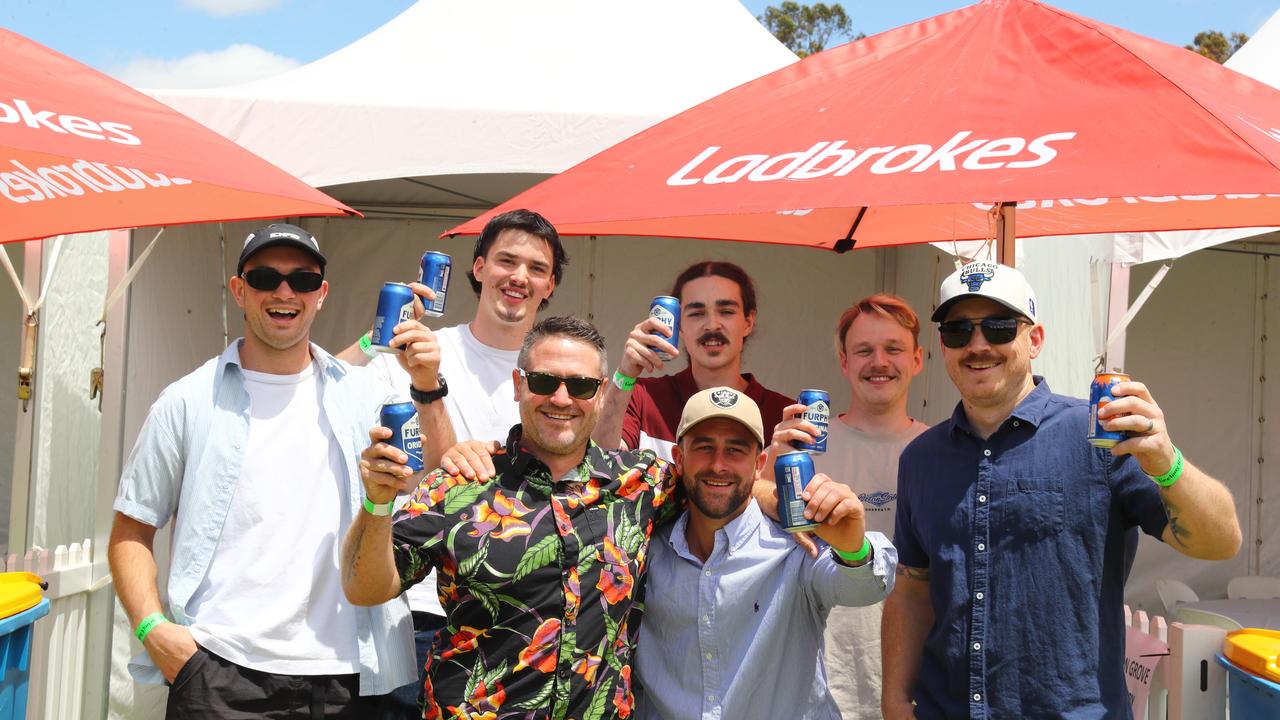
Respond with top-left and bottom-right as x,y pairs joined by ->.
882,263 -> 1240,720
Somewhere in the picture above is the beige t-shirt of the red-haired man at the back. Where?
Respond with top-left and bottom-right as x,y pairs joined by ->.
813,418 -> 928,720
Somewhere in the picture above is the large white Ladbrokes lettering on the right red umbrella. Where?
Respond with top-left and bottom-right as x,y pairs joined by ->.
667,131 -> 1075,186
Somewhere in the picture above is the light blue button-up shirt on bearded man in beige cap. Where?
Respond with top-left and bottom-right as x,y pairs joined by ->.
636,500 -> 896,720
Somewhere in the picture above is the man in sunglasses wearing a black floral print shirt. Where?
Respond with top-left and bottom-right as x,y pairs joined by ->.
342,318 -> 676,720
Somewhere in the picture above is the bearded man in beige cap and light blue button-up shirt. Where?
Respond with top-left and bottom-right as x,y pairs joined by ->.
636,387 -> 897,720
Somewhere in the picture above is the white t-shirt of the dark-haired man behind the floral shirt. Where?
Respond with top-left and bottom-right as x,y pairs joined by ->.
369,323 -> 520,615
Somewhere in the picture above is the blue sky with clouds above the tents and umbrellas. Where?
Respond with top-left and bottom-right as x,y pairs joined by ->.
0,0 -> 1280,87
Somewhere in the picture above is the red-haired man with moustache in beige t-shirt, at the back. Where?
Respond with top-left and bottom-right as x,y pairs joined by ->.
780,295 -> 928,720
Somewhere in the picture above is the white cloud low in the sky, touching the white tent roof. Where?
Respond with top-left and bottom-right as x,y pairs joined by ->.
110,45 -> 301,90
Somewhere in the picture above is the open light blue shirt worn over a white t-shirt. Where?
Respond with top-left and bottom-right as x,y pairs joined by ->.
114,340 -> 417,694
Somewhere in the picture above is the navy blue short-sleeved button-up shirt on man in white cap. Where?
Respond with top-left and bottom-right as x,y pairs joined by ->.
893,377 -> 1167,720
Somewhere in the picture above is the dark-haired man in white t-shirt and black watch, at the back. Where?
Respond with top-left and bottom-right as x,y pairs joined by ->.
339,210 -> 568,717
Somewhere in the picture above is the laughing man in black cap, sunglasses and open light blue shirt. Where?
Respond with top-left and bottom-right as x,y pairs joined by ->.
108,223 -> 415,719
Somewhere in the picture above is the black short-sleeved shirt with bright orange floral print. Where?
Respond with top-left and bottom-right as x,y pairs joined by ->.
392,425 -> 676,720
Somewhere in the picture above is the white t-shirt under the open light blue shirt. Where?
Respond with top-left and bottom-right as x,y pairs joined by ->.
187,364 -> 360,675
